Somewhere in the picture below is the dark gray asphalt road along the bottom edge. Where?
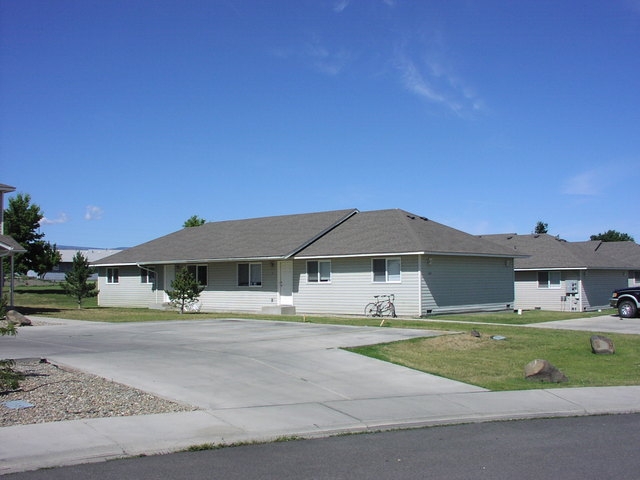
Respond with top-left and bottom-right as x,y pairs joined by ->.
5,414 -> 640,480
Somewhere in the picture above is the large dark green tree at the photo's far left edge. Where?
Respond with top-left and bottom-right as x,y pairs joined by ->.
4,193 -> 60,274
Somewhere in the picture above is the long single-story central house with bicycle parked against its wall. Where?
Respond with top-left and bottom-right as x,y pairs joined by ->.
94,209 -> 517,316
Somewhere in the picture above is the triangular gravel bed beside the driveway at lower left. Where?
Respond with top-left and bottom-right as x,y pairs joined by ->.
0,359 -> 197,427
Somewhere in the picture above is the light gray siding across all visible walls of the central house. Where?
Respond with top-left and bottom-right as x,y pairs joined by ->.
98,255 -> 513,316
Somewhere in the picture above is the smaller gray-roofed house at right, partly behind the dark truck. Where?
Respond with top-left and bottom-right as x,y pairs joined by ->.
481,234 -> 640,312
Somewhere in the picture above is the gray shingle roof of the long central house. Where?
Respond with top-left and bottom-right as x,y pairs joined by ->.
95,209 -> 514,265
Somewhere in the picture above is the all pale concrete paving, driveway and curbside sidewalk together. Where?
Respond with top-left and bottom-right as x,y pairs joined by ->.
0,320 -> 640,473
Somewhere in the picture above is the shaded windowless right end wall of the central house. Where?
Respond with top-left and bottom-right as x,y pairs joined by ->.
422,255 -> 514,315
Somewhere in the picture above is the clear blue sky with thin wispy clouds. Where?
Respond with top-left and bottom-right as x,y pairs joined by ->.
0,0 -> 640,248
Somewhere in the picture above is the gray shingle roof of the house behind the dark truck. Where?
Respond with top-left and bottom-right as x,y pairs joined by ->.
482,233 -> 640,270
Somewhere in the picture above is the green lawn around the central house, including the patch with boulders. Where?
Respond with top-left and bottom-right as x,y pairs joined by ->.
7,284 -> 640,390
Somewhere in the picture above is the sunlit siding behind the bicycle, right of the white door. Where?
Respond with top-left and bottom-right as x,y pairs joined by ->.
293,255 -> 420,316
